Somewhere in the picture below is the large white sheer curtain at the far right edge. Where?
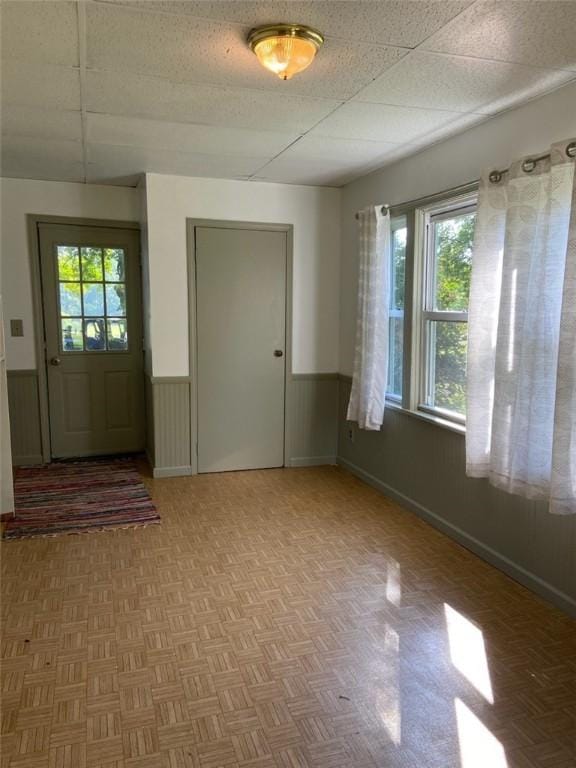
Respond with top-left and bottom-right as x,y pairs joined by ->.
466,141 -> 576,514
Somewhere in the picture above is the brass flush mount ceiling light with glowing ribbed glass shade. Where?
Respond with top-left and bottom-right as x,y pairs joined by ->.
248,24 -> 324,80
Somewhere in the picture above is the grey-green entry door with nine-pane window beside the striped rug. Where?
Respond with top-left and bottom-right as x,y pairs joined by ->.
38,224 -> 145,458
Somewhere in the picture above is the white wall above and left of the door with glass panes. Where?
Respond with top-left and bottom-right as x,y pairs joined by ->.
0,179 -> 141,370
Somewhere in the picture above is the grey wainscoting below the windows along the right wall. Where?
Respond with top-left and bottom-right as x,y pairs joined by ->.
338,376 -> 576,615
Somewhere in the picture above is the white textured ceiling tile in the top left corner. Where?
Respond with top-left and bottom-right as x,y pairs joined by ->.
1,0 -> 78,67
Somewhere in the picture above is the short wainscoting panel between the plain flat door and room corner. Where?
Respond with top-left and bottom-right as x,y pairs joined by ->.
286,373 -> 338,467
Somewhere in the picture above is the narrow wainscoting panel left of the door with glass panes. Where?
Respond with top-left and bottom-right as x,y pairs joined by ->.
7,370 -> 43,466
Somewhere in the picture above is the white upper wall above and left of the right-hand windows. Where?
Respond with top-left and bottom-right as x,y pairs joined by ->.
340,82 -> 576,374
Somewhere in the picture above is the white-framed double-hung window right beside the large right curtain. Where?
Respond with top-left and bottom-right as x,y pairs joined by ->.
418,197 -> 476,423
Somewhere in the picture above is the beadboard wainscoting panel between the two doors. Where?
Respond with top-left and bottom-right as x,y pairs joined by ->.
146,376 -> 192,477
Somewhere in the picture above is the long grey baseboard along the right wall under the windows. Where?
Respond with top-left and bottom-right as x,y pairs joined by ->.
337,456 -> 576,618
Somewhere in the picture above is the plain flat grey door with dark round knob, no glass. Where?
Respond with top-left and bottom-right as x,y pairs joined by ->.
196,227 -> 287,472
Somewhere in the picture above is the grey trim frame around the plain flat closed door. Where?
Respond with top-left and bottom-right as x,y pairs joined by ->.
186,218 -> 294,475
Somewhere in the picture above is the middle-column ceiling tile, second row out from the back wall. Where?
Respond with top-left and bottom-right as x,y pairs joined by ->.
88,114 -> 298,158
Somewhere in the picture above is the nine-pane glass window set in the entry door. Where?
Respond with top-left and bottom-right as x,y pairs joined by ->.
56,245 -> 128,352
